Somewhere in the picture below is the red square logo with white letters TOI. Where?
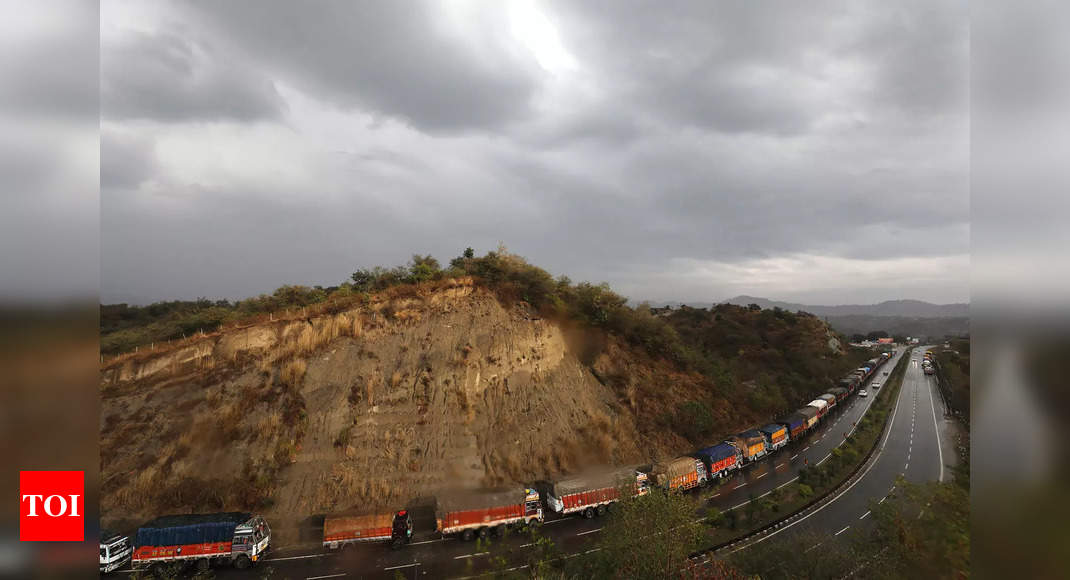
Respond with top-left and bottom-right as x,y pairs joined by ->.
18,471 -> 86,541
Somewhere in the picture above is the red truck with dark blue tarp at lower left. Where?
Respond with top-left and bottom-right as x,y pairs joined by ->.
132,512 -> 271,569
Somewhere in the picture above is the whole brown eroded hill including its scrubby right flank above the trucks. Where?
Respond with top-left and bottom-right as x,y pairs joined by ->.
101,253 -> 868,543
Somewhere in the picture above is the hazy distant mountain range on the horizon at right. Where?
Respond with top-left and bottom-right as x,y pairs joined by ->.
652,295 -> 969,337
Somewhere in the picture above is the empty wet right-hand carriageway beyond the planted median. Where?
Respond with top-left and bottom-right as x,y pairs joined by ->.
731,347 -> 958,547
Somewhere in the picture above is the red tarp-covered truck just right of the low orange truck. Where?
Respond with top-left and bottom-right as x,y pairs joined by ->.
434,488 -> 542,540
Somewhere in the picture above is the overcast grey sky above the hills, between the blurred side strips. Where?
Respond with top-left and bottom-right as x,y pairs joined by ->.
100,0 -> 969,304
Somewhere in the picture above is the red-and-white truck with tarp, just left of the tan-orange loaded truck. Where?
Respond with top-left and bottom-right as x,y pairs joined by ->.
539,468 -> 647,519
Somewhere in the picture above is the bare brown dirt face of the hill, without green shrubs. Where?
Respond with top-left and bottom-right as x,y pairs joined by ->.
102,279 -> 642,543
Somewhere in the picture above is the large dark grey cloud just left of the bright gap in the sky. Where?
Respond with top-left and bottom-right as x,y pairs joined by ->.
184,1 -> 537,132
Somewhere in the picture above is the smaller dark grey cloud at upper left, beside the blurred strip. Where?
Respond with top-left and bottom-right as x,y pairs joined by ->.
101,32 -> 282,121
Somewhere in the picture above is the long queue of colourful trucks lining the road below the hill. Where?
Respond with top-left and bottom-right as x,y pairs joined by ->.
101,351 -> 894,573
